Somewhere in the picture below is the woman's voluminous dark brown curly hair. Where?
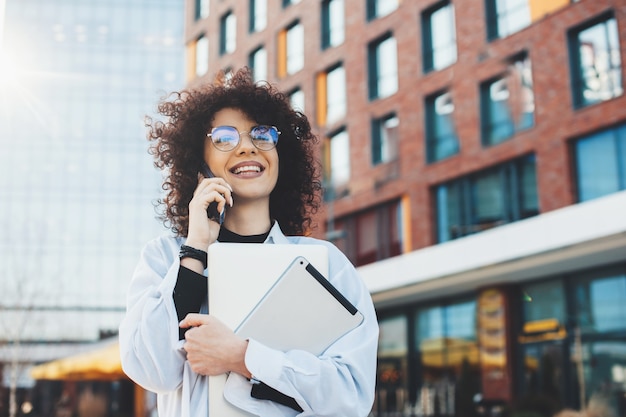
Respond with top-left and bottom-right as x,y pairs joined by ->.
146,68 -> 322,236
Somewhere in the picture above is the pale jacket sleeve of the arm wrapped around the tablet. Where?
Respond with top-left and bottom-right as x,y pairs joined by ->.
225,249 -> 378,417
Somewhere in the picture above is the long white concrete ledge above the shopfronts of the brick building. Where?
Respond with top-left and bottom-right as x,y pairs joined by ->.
358,191 -> 626,306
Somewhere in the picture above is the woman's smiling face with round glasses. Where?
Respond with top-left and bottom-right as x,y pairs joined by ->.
204,108 -> 278,206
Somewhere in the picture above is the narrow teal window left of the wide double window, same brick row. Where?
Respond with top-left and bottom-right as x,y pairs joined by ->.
426,92 -> 459,163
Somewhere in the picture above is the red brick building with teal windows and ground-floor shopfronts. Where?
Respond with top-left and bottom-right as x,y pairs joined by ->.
185,0 -> 626,416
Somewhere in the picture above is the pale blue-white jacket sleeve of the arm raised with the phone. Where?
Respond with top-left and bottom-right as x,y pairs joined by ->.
119,238 -> 195,393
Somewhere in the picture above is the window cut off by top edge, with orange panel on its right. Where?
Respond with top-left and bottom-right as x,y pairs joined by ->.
486,0 -> 531,40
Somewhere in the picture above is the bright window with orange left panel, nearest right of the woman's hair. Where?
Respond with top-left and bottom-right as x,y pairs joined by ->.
317,65 -> 346,126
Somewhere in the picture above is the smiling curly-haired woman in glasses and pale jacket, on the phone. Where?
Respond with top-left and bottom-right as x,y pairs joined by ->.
119,70 -> 378,417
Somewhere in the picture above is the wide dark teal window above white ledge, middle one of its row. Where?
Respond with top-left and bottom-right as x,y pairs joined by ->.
434,155 -> 539,243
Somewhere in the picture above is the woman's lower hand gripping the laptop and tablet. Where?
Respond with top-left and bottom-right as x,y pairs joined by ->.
180,313 -> 251,378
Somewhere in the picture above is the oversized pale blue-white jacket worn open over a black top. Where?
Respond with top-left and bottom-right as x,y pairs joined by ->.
119,223 -> 378,417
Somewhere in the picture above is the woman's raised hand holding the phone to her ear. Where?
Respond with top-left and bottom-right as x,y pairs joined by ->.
185,176 -> 233,251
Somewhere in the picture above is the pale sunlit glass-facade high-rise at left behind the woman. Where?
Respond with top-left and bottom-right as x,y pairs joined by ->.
0,0 -> 185,341
